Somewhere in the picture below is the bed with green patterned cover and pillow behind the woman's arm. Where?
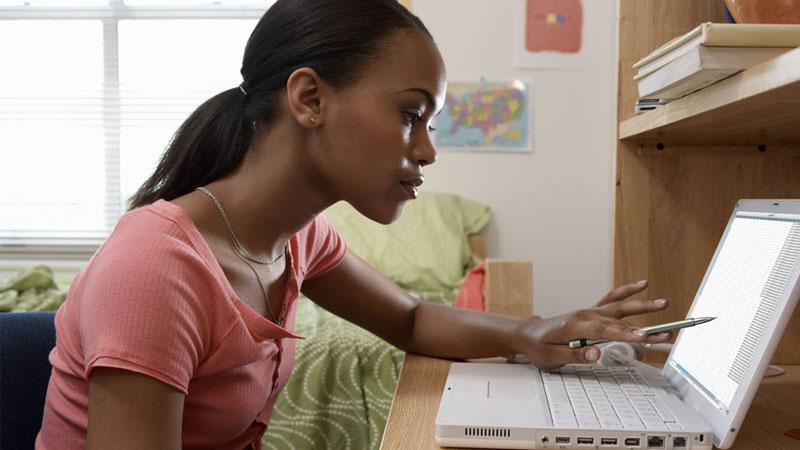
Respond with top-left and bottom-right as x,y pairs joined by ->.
262,193 -> 531,450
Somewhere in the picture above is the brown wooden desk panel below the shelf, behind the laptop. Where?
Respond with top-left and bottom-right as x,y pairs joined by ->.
616,147 -> 800,364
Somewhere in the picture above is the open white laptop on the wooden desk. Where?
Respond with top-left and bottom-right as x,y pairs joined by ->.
436,200 -> 800,450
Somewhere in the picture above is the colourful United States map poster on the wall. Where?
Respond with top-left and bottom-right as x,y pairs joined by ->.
435,80 -> 531,153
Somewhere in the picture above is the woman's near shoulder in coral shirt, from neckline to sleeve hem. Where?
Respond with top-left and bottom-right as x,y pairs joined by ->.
66,205 -> 225,384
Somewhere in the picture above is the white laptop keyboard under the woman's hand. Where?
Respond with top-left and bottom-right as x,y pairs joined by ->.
541,366 -> 683,430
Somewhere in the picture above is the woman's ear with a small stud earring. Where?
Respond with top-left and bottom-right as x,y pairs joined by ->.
286,67 -> 324,128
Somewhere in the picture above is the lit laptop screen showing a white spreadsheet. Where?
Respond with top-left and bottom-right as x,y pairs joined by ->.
668,211 -> 800,415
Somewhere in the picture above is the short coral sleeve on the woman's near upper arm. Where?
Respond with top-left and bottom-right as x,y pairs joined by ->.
80,217 -> 213,393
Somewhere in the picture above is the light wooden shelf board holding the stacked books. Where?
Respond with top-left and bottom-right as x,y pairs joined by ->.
619,48 -> 800,145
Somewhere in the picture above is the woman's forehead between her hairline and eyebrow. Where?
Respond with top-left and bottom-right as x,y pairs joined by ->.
357,31 -> 447,110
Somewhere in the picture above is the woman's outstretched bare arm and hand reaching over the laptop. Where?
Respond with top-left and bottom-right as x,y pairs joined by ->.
303,251 -> 671,367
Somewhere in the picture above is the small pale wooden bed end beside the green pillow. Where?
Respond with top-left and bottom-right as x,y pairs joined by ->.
484,259 -> 533,317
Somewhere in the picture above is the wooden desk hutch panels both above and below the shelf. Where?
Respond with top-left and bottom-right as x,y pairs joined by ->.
614,0 -> 800,364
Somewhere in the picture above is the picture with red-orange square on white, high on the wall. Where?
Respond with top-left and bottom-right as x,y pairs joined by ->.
514,0 -> 592,69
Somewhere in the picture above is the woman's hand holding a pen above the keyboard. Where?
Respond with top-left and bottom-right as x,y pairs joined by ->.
514,280 -> 672,369
